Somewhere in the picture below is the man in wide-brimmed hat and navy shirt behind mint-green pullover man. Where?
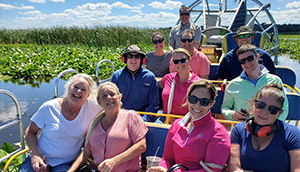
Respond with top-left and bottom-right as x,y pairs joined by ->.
215,26 -> 276,80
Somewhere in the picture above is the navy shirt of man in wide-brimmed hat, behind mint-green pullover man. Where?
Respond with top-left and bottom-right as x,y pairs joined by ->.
215,47 -> 276,81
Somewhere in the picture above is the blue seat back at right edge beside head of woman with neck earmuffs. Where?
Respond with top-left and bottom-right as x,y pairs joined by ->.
286,92 -> 300,126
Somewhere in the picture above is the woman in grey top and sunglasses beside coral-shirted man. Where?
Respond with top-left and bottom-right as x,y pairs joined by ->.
143,31 -> 172,78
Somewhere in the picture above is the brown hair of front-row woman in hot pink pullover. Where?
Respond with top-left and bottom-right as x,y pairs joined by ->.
183,79 -> 217,106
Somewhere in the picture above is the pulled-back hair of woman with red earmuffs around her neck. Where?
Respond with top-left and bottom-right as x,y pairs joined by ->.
248,83 -> 284,113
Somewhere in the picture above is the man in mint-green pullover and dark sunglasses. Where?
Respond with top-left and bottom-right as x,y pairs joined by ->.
221,44 -> 289,121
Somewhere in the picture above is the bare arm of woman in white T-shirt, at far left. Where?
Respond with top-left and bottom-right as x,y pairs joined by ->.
25,122 -> 47,171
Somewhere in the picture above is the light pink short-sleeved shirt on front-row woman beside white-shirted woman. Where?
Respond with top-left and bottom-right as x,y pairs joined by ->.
86,110 -> 148,172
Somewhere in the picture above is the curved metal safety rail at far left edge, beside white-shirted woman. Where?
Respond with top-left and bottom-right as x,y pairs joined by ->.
0,89 -> 25,163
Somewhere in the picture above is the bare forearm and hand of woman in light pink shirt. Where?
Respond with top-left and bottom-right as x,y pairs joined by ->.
98,137 -> 146,172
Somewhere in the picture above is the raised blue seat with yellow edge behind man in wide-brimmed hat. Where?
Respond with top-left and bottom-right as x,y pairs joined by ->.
219,32 -> 264,63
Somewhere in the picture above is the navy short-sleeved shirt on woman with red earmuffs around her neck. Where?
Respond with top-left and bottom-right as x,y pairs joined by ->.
230,120 -> 300,172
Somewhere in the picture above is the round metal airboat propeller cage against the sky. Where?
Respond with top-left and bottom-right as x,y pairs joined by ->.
184,0 -> 279,64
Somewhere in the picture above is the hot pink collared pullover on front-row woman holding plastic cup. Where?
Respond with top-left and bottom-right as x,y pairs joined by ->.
160,111 -> 230,172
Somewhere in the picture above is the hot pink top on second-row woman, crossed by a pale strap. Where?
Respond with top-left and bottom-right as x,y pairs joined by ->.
161,71 -> 201,115
